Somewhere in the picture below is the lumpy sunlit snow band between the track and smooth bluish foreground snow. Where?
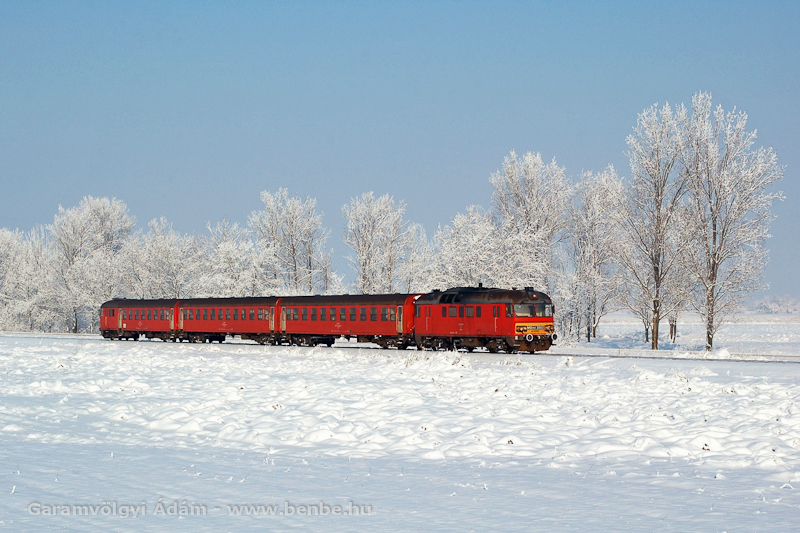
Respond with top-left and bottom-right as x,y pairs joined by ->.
6,338 -> 800,466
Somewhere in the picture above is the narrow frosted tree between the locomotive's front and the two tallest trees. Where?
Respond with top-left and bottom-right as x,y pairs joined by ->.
562,166 -> 622,342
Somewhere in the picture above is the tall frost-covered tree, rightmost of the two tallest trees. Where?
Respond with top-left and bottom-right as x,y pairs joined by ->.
680,92 -> 783,350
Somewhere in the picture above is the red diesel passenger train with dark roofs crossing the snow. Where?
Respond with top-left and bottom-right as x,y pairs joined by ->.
100,285 -> 557,353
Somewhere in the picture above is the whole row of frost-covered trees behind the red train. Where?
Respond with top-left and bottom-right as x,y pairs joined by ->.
0,92 -> 783,349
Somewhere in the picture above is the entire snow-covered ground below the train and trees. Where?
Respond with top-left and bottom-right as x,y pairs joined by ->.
0,316 -> 800,531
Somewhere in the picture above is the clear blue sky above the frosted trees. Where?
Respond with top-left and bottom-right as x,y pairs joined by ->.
0,1 -> 800,297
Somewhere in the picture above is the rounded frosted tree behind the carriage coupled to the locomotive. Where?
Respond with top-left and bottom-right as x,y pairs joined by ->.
342,192 -> 413,294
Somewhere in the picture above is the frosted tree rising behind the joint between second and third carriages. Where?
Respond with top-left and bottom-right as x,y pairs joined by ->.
249,189 -> 331,294
